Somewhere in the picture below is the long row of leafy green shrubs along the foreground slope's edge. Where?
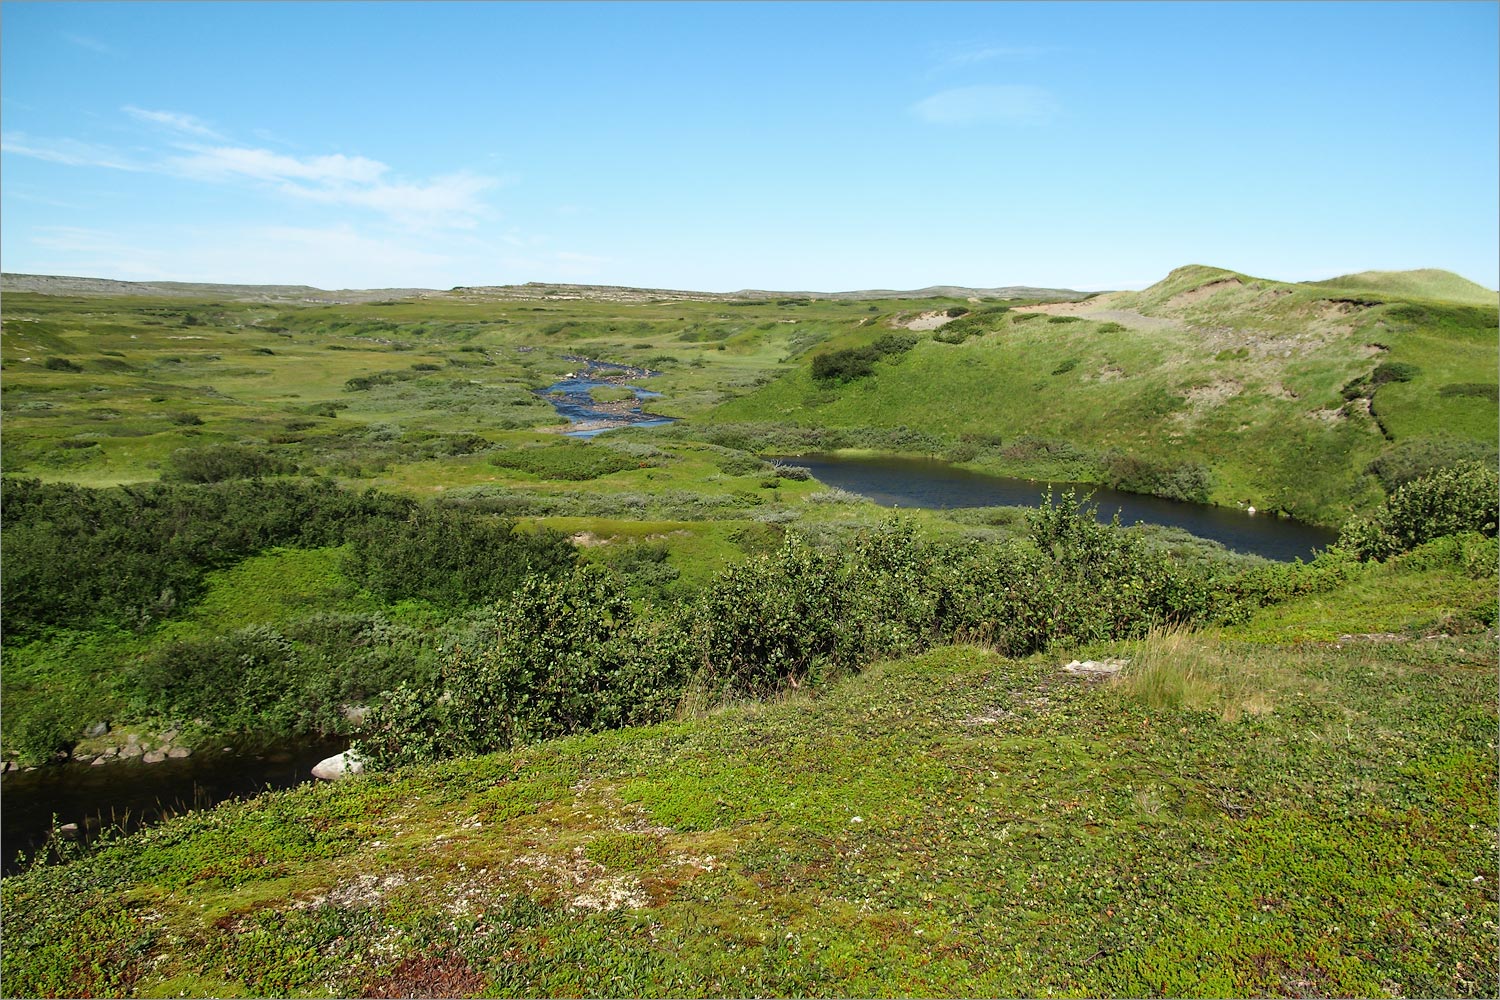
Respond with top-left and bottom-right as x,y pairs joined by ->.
357,495 -> 1238,765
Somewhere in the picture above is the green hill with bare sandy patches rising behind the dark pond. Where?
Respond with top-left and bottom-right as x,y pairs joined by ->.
710,267 -> 1500,525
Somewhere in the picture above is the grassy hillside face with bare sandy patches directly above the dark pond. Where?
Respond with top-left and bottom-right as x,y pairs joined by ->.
711,267 -> 1500,525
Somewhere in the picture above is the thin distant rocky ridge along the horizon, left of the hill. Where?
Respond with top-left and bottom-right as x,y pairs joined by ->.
0,271 -> 1092,304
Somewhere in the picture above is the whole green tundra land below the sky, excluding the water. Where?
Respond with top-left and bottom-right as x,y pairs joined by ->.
0,267 -> 1500,996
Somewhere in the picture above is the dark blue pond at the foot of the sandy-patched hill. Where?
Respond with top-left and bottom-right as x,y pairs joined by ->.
783,456 -> 1338,562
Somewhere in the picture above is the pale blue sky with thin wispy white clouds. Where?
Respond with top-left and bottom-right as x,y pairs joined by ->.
0,3 -> 1500,291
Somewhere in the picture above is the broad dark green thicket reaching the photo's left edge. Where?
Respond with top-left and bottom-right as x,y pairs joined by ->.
0,478 -> 411,637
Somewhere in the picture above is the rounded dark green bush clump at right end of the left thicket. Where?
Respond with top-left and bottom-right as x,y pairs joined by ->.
345,505 -> 576,607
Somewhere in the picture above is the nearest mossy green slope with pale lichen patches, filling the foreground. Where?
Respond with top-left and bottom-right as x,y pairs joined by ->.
3,556 -> 1500,996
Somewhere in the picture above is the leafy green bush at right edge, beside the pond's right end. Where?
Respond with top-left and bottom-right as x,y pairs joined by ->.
1338,462 -> 1500,561
